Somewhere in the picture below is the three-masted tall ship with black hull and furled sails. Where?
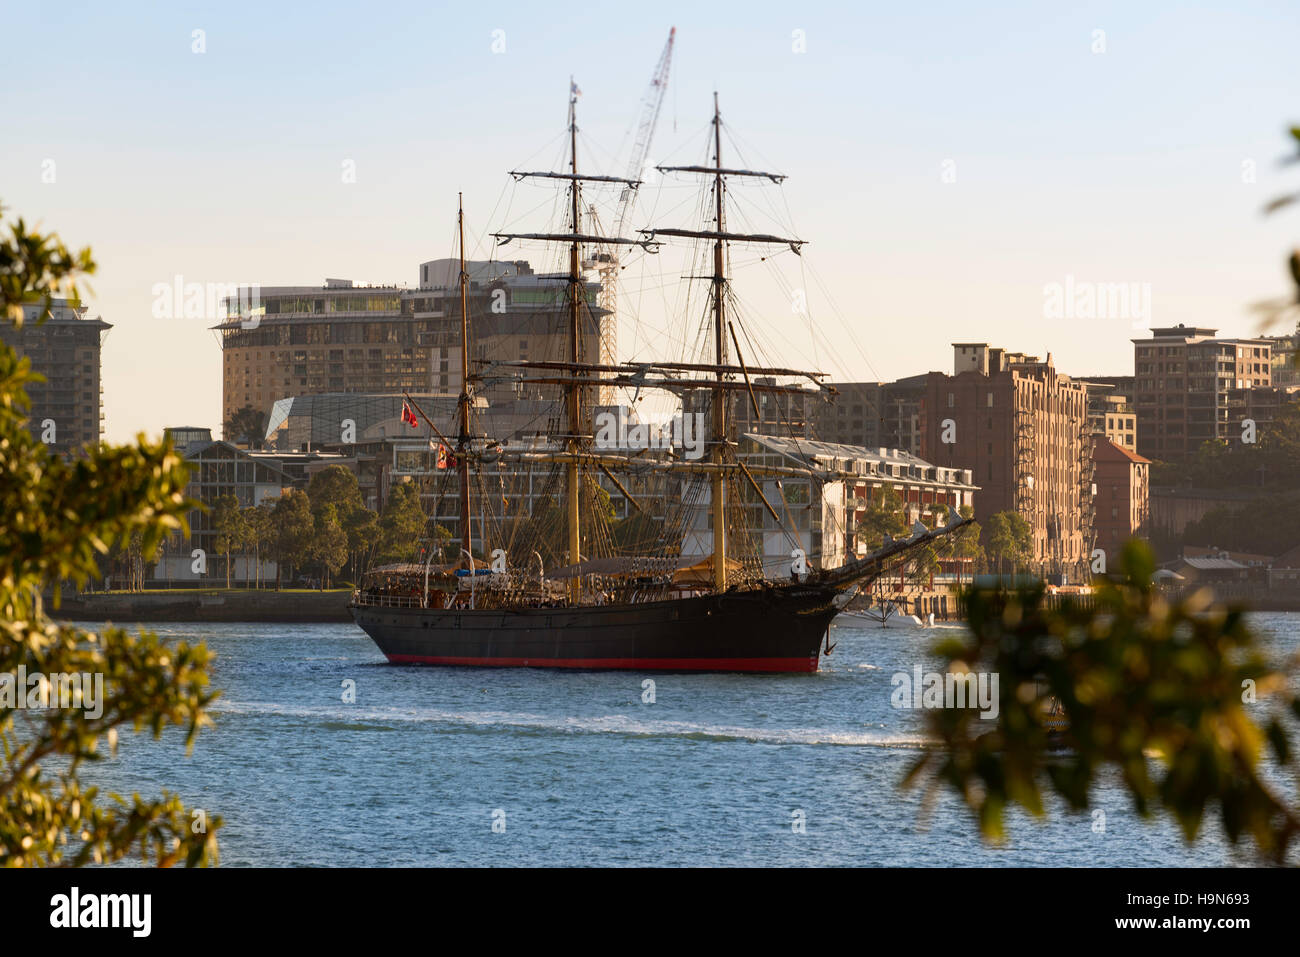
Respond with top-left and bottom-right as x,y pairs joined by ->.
350,86 -> 969,672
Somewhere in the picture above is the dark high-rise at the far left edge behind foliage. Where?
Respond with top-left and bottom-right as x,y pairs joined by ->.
0,299 -> 112,455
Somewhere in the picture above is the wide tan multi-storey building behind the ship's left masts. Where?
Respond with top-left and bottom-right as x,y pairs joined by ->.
215,260 -> 614,429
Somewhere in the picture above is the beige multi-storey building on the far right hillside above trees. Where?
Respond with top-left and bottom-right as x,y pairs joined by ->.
1132,325 -> 1281,462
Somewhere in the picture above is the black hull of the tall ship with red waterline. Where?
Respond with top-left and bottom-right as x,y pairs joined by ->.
351,584 -> 839,672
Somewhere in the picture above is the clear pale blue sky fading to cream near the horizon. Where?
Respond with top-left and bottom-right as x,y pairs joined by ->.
0,0 -> 1300,441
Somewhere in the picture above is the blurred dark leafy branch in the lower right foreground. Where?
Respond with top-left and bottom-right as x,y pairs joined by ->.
905,542 -> 1300,861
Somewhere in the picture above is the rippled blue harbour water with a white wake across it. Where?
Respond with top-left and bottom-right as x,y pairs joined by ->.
76,615 -> 1300,866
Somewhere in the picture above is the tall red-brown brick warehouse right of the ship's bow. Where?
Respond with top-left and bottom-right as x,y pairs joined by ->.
920,342 -> 1093,581
